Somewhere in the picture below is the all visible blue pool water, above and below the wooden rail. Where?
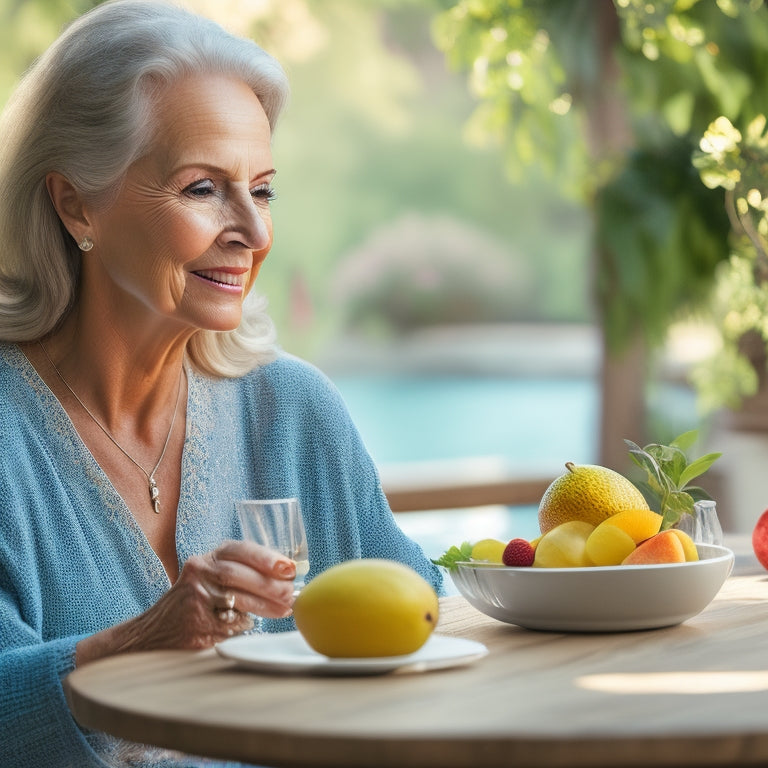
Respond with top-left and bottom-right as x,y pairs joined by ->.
332,373 -> 695,557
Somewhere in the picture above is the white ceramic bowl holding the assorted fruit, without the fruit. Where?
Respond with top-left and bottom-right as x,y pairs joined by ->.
451,544 -> 734,632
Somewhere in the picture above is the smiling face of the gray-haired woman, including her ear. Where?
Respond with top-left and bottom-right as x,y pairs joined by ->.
83,75 -> 275,331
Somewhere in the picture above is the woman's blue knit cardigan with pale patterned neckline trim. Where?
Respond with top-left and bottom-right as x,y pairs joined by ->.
0,344 -> 442,768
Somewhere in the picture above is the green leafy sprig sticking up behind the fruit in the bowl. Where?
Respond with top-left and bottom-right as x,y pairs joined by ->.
624,429 -> 722,530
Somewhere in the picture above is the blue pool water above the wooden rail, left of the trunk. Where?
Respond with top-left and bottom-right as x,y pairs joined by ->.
335,374 -> 599,468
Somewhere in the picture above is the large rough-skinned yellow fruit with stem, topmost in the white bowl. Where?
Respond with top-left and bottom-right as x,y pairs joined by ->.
539,462 -> 648,533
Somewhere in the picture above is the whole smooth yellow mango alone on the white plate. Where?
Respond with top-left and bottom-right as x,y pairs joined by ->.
293,559 -> 438,658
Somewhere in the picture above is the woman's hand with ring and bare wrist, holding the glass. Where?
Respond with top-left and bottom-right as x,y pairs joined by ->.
76,541 -> 296,666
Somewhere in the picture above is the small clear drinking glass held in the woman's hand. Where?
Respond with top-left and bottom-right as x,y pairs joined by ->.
235,498 -> 309,632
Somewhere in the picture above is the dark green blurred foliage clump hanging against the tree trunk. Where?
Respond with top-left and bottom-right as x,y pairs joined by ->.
595,137 -> 730,351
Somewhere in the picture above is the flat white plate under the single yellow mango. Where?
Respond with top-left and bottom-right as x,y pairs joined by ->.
216,632 -> 488,675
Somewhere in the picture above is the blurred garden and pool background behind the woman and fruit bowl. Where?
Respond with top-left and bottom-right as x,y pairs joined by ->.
6,0 -> 768,556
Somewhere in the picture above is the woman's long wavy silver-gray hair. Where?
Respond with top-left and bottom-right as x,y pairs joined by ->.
0,0 -> 288,376
